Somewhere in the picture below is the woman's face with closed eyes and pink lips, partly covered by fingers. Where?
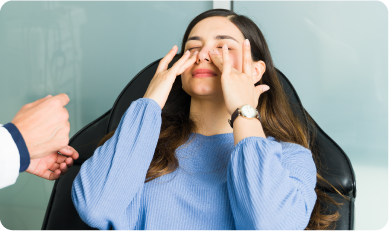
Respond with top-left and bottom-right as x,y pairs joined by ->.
181,16 -> 244,98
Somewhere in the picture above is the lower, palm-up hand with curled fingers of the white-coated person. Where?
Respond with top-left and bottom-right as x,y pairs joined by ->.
26,146 -> 79,180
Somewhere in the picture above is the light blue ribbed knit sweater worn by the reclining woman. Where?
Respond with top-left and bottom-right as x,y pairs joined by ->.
72,98 -> 316,230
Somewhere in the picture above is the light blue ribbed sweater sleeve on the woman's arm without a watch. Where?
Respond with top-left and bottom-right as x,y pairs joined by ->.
72,98 -> 162,229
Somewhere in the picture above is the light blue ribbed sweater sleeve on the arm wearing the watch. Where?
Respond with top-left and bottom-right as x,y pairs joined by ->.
227,137 -> 316,230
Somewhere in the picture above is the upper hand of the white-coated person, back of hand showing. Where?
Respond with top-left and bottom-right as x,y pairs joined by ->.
12,94 -> 70,160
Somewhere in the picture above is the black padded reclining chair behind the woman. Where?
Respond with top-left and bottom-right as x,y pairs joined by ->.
42,58 -> 356,230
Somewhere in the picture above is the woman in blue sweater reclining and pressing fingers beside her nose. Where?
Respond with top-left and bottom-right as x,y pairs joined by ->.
72,9 -> 342,229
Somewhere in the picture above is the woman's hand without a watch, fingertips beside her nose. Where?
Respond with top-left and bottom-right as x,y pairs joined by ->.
143,45 -> 197,109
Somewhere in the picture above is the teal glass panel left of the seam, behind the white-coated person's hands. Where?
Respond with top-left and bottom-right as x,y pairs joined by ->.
0,1 -> 212,230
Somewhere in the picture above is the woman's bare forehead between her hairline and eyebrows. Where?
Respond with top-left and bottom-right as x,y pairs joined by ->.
189,16 -> 244,41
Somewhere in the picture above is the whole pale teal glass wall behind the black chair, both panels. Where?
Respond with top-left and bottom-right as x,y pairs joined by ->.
0,1 -> 388,230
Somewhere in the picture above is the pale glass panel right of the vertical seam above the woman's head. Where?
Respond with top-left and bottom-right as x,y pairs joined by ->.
234,1 -> 388,229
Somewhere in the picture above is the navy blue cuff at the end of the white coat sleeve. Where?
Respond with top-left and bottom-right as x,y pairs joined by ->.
3,123 -> 30,172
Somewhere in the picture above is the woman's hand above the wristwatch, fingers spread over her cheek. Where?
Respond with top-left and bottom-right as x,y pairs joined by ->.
210,40 -> 269,115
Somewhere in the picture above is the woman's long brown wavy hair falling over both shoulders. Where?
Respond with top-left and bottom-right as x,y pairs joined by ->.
98,9 -> 348,230
